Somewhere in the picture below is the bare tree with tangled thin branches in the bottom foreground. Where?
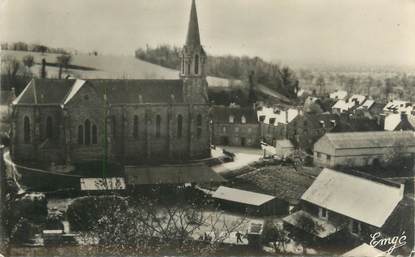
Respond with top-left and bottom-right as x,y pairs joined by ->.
74,193 -> 248,256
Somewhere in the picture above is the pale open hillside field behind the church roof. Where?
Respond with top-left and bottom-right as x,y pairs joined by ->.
0,50 -> 241,87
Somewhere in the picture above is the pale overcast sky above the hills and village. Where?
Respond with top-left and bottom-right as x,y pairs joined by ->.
0,0 -> 415,66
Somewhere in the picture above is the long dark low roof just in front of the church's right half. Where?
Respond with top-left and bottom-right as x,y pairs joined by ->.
125,163 -> 226,185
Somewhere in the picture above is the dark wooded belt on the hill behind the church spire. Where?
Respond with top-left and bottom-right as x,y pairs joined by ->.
135,44 -> 299,98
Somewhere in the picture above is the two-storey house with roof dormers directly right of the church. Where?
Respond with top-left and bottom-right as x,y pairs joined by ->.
210,106 -> 261,147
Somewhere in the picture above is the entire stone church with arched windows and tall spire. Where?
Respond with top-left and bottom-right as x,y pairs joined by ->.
11,0 -> 210,164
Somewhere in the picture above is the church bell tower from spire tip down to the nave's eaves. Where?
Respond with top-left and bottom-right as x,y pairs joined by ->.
180,0 -> 208,103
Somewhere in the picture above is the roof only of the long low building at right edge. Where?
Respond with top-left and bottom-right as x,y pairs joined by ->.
323,131 -> 415,149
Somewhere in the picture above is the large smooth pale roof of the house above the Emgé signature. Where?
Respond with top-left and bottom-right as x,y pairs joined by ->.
301,168 -> 403,228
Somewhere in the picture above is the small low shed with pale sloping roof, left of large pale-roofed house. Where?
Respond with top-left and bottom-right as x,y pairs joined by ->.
212,186 -> 286,216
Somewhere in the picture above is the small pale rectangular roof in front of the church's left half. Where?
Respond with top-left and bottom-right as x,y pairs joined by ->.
80,178 -> 125,191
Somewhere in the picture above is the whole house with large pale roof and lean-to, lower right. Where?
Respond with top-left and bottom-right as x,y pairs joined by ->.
283,168 -> 406,244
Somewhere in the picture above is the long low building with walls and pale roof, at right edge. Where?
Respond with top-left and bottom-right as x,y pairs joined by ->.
313,131 -> 415,167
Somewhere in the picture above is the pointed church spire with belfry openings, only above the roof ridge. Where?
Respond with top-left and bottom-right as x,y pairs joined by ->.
180,0 -> 206,78
